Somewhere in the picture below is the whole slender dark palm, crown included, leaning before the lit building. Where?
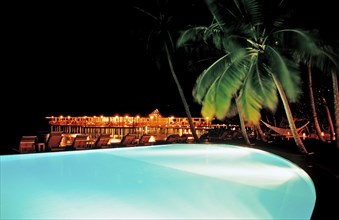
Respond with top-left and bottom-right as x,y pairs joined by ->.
134,1 -> 199,143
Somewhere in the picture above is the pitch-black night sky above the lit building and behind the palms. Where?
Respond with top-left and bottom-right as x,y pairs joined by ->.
0,0 -> 339,150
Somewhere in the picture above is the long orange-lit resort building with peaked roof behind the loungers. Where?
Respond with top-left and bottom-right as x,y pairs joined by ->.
46,109 -> 225,146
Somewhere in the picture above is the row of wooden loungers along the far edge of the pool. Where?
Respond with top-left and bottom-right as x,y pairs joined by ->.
13,132 -> 193,153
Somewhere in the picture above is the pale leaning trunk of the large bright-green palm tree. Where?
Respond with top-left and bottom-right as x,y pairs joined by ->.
272,74 -> 308,154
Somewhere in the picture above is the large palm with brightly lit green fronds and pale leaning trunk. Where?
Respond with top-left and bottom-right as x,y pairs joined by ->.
177,0 -> 326,153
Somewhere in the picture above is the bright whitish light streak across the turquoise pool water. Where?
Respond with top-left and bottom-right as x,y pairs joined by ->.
117,144 -> 294,186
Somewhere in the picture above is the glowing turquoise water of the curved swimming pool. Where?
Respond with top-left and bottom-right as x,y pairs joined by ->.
0,144 -> 316,219
